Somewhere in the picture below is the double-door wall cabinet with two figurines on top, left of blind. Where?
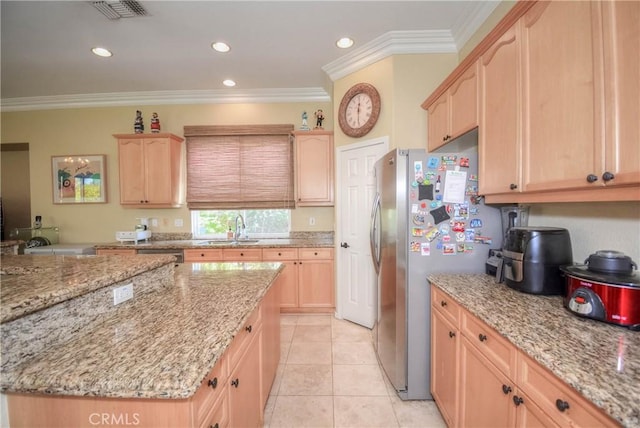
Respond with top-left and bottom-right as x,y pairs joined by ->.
114,134 -> 184,208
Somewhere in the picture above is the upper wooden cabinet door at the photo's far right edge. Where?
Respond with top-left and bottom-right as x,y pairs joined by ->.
600,1 -> 640,186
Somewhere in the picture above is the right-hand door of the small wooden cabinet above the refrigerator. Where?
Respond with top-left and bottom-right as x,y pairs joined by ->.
449,62 -> 478,138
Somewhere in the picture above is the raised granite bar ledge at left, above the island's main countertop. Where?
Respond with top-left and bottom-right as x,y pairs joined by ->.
0,255 -> 175,323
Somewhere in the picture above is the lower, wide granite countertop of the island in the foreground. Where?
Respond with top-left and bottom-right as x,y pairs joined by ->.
0,256 -> 282,399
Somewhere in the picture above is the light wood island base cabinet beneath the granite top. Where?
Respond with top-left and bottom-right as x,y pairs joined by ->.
7,276 -> 281,428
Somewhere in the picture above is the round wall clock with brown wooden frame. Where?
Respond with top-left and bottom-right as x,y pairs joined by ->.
338,83 -> 380,138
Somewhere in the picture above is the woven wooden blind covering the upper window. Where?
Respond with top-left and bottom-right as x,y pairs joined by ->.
185,126 -> 295,209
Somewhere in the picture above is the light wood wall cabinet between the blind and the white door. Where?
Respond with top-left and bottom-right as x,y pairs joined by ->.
293,131 -> 334,207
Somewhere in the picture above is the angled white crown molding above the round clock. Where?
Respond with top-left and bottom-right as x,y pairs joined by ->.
322,30 -> 458,81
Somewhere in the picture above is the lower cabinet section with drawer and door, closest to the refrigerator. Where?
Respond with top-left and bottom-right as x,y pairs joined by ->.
431,287 -> 460,427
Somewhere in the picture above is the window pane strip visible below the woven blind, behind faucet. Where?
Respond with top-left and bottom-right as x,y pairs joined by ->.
191,209 -> 291,239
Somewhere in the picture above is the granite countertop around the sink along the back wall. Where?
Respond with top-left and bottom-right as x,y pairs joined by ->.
95,238 -> 333,250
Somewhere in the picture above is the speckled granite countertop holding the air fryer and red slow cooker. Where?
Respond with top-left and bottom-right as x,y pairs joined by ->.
428,274 -> 640,427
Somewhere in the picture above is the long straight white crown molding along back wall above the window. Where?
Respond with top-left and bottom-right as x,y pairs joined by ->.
1,88 -> 331,112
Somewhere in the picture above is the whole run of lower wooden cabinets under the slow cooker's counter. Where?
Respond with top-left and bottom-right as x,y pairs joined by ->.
431,286 -> 619,428
